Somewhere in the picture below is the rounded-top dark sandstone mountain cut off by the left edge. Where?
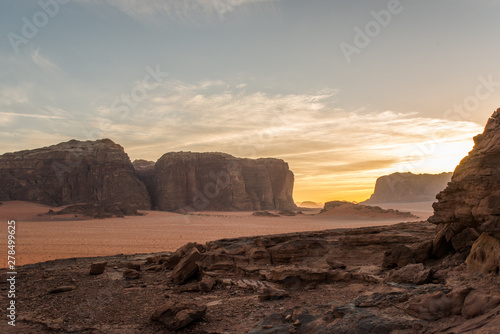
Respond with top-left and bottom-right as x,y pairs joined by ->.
0,139 -> 151,209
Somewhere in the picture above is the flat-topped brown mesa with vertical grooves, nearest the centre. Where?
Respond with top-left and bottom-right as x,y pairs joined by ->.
153,152 -> 296,211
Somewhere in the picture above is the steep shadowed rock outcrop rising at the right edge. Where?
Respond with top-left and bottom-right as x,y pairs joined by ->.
429,108 -> 500,257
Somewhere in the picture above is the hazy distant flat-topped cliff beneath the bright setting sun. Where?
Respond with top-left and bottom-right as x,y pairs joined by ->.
364,173 -> 452,204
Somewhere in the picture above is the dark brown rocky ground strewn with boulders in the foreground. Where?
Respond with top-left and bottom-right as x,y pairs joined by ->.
0,222 -> 500,333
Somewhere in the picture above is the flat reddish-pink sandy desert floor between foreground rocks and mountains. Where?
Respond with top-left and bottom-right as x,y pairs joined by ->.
0,201 -> 432,268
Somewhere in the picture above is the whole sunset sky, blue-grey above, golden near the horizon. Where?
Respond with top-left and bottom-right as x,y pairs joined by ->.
0,0 -> 500,202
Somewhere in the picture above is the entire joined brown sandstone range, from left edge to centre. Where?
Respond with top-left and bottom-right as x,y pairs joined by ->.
0,139 -> 296,211
